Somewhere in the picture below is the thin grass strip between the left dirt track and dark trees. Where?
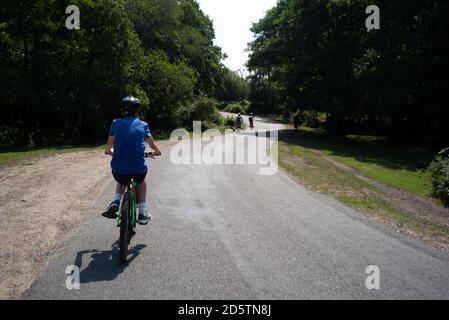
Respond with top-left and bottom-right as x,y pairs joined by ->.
0,144 -> 104,166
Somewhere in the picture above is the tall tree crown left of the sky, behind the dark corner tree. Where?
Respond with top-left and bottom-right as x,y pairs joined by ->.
127,0 -> 222,95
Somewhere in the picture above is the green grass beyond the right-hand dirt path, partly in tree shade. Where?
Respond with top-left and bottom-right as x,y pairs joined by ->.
284,128 -> 437,201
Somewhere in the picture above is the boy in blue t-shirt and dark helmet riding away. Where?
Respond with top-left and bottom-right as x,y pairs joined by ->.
102,97 -> 161,225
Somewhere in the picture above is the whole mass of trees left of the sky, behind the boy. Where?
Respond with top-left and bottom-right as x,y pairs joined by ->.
0,0 -> 247,146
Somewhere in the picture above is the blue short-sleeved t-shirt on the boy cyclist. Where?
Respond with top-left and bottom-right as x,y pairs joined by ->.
109,117 -> 151,174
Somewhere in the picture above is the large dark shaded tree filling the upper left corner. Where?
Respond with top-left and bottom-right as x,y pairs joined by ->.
0,0 -> 143,144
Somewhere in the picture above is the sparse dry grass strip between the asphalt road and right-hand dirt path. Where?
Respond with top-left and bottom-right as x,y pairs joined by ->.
279,133 -> 449,250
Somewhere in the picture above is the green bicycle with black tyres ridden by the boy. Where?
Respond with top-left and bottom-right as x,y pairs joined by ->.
117,152 -> 158,263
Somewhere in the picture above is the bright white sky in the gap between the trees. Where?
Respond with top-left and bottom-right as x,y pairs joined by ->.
197,0 -> 277,73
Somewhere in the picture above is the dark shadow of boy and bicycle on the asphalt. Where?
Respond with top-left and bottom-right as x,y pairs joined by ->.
74,241 -> 147,283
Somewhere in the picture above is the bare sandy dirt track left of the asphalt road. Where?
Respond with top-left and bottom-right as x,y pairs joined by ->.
0,150 -> 112,299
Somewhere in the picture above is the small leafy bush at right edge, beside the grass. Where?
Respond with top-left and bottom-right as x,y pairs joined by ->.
429,148 -> 449,205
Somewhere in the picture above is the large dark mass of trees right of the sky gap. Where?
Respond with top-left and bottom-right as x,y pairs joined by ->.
248,0 -> 449,146
